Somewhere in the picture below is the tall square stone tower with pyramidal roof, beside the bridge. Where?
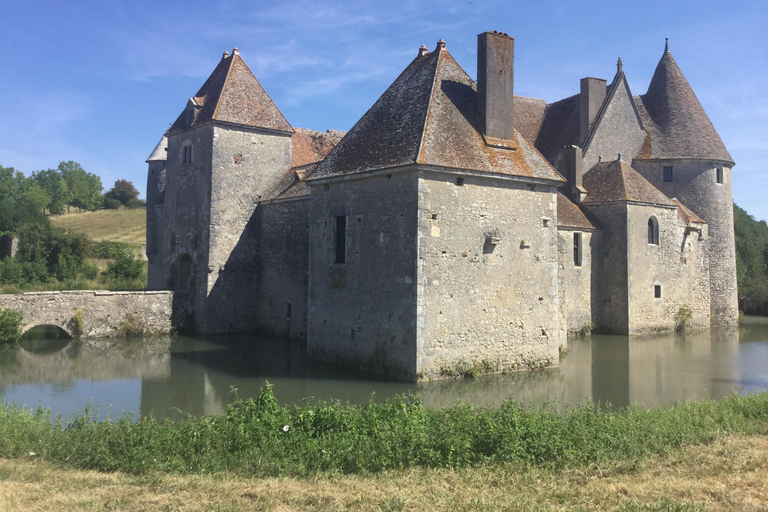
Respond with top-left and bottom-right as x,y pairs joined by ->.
149,48 -> 293,332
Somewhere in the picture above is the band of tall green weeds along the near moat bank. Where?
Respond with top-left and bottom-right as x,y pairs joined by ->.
0,386 -> 768,476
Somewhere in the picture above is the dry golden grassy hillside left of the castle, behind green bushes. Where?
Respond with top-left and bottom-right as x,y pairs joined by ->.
50,208 -> 147,245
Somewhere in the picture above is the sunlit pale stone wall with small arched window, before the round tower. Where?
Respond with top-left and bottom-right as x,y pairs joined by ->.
627,204 -> 710,334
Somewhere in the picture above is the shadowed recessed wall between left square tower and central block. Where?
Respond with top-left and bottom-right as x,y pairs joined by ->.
252,197 -> 309,338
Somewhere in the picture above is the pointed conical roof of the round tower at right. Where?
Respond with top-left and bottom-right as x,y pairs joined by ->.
637,49 -> 733,163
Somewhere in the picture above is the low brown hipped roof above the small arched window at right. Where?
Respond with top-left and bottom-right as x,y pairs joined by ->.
583,160 -> 675,206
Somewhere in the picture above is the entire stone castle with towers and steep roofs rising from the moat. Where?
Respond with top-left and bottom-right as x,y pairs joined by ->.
147,32 -> 738,380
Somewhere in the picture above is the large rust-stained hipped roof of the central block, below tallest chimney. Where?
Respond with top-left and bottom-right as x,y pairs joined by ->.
312,42 -> 564,181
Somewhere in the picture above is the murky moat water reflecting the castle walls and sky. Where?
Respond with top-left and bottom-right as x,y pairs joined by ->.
0,317 -> 768,419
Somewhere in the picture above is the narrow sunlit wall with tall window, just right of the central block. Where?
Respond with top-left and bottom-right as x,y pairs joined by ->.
557,228 -> 602,336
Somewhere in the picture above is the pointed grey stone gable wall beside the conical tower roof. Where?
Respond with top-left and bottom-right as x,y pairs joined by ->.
584,83 -> 645,171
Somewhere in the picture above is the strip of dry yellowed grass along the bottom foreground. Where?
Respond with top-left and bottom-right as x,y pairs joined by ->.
0,436 -> 768,512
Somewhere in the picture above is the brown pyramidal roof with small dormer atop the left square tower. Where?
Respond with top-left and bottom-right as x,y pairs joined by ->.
168,48 -> 293,133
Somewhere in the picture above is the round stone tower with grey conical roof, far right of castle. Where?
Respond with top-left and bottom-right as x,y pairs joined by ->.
632,45 -> 739,323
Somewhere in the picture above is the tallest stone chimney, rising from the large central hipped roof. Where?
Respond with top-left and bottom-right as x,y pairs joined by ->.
477,31 -> 515,139
